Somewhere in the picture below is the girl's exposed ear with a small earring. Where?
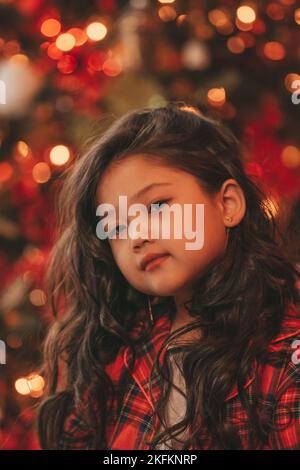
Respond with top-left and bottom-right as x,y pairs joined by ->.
219,179 -> 246,227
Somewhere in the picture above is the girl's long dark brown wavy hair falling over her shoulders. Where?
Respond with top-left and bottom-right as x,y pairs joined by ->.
38,102 -> 299,449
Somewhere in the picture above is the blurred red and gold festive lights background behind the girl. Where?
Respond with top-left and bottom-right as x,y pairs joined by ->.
0,0 -> 300,449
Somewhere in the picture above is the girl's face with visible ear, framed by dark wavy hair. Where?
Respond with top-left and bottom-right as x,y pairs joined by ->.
97,155 -> 245,297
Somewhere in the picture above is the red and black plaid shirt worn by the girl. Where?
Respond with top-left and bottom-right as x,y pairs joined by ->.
59,306 -> 300,450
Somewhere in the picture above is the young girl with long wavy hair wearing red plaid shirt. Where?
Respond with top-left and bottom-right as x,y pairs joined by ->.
38,103 -> 300,450
